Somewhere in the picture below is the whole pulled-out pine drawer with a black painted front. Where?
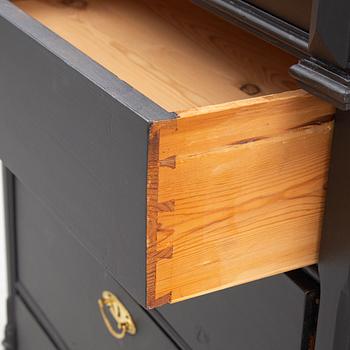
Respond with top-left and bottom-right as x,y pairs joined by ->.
0,0 -> 334,308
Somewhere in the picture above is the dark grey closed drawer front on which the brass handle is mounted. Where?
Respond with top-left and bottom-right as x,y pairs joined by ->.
15,181 -> 176,350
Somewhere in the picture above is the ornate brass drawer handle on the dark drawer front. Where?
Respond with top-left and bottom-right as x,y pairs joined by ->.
98,291 -> 136,339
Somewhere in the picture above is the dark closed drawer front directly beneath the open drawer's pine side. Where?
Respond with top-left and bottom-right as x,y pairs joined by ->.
157,270 -> 319,350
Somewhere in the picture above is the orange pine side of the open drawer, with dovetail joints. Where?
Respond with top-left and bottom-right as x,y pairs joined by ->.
147,91 -> 334,307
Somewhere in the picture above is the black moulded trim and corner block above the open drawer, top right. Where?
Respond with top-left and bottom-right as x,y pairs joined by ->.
193,0 -> 350,111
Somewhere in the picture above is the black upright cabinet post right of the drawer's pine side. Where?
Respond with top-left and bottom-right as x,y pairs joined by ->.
316,111 -> 350,350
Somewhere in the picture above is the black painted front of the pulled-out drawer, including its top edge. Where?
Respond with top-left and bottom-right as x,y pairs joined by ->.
0,0 -> 172,303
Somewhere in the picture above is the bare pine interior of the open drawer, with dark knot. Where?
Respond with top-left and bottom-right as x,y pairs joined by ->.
14,0 -> 297,111
